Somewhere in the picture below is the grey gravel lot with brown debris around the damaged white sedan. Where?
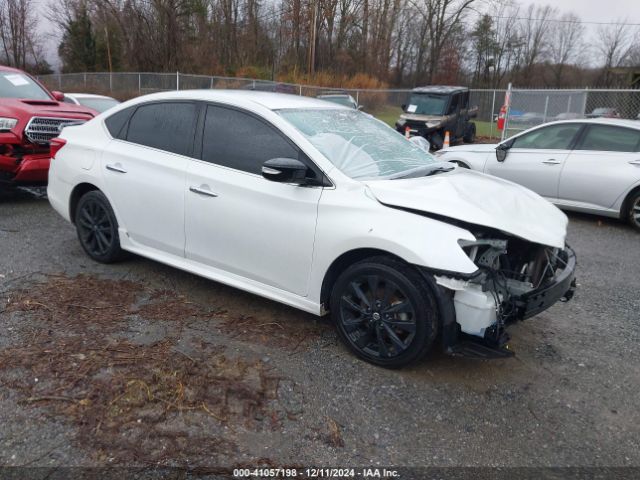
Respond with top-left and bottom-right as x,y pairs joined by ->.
0,188 -> 640,469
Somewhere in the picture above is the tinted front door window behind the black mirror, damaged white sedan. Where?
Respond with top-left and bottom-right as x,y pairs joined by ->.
202,105 -> 298,175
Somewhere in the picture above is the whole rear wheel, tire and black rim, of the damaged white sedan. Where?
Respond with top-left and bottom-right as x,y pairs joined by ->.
75,190 -> 125,263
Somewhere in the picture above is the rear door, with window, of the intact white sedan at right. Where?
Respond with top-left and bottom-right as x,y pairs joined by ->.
559,124 -> 640,209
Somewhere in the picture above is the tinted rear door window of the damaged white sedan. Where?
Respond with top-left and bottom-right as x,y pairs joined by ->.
127,102 -> 196,155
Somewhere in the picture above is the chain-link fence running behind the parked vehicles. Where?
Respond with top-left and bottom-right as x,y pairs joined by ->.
39,72 -> 640,138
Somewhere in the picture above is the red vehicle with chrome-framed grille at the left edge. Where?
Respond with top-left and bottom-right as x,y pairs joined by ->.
0,65 -> 97,188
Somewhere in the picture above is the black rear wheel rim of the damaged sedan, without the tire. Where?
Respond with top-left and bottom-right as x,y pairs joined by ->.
77,200 -> 115,257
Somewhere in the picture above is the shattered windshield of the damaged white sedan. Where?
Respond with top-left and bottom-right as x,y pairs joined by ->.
278,108 -> 436,180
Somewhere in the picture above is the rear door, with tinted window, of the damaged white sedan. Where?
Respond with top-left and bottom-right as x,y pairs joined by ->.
102,102 -> 198,256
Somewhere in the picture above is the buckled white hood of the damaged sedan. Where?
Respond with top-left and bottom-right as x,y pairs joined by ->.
364,168 -> 568,248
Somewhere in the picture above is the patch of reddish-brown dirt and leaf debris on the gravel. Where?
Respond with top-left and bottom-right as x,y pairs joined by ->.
0,276 -> 299,465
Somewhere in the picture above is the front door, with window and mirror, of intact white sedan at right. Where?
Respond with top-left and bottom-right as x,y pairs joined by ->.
485,123 -> 582,200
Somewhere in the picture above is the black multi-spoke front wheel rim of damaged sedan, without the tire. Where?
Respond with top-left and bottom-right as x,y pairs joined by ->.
340,275 -> 416,358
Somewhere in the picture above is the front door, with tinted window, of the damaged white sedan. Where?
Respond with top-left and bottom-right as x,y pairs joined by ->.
185,105 -> 322,296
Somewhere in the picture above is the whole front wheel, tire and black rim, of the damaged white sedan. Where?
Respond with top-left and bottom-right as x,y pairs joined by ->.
330,257 -> 439,368
